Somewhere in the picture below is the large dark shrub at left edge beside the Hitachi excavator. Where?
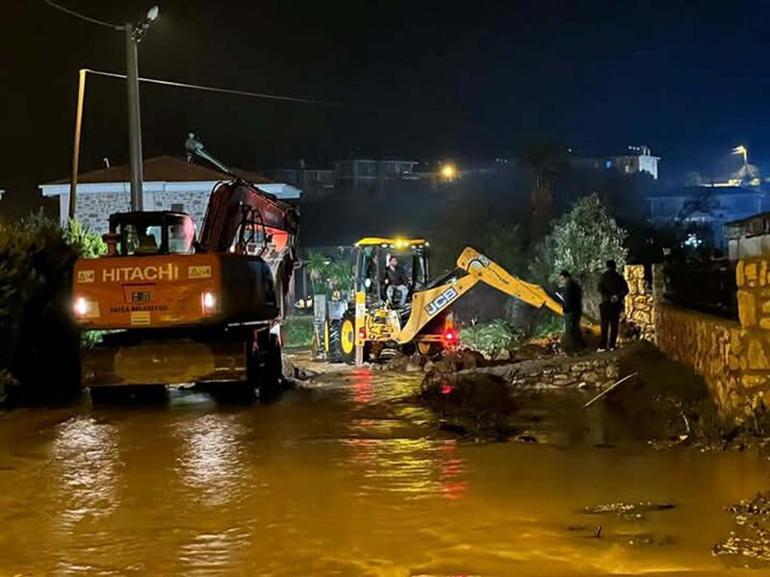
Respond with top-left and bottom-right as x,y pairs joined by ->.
0,213 -> 103,401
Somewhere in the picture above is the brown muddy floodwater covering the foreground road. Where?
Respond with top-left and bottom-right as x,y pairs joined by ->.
0,370 -> 770,577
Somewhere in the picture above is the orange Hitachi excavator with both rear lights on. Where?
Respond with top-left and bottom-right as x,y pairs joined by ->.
72,135 -> 299,396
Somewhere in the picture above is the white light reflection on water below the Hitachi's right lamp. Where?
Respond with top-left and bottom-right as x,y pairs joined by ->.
174,414 -> 248,506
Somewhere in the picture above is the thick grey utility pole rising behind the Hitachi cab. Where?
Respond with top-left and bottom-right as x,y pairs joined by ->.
125,22 -> 144,211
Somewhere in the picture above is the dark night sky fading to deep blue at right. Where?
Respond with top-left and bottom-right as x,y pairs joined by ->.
0,0 -> 770,211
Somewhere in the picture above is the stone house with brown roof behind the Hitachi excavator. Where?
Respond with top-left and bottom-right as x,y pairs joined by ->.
40,156 -> 302,232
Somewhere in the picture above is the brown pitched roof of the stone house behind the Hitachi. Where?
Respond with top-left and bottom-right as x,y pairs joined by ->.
43,156 -> 271,186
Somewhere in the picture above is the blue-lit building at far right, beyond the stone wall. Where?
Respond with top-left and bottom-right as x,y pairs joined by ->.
647,186 -> 770,246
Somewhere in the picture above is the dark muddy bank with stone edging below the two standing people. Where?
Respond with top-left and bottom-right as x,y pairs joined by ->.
418,343 -> 770,450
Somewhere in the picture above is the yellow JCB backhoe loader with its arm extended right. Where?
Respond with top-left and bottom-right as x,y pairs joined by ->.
317,237 -> 562,365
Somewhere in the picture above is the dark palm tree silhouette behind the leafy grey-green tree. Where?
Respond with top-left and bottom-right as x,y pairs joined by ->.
519,139 -> 569,241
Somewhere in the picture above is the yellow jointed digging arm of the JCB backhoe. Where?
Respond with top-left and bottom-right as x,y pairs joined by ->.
396,247 -> 563,344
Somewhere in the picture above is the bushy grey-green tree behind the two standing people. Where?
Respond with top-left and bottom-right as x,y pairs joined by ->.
530,194 -> 628,314
